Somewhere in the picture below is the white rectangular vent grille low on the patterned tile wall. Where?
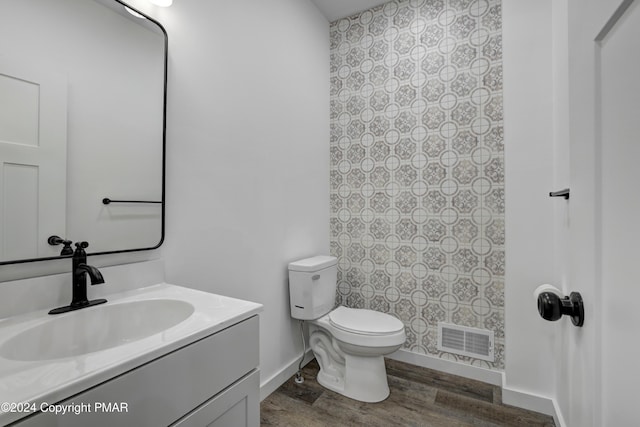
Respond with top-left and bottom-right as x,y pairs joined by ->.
438,322 -> 494,362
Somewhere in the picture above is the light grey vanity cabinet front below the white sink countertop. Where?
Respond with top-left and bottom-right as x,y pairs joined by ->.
11,315 -> 260,427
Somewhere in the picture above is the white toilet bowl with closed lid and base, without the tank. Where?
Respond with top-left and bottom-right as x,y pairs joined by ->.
309,307 -> 406,402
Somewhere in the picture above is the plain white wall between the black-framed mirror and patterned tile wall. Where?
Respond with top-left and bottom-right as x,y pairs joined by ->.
132,0 -> 329,392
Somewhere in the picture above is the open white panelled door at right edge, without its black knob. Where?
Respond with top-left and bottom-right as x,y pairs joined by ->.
558,0 -> 640,427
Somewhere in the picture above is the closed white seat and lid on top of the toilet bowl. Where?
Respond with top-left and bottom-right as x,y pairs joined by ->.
329,306 -> 404,335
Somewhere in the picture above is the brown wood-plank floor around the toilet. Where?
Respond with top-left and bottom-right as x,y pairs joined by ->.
260,359 -> 555,427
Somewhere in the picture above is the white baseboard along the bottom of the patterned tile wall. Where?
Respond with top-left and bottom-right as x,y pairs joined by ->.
387,349 -> 504,386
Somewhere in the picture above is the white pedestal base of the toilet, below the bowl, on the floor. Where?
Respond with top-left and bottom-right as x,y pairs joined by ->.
317,354 -> 389,403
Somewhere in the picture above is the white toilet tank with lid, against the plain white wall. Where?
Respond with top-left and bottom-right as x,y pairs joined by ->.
289,255 -> 338,320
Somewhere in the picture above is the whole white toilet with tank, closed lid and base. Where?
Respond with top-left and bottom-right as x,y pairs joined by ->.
289,256 -> 406,402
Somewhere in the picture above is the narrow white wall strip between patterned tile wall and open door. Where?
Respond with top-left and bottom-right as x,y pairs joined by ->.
503,0 -> 564,413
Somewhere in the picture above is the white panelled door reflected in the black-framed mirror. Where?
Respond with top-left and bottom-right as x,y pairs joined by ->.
0,57 -> 67,261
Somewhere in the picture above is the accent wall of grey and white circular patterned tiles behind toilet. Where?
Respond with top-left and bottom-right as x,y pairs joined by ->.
330,0 -> 504,369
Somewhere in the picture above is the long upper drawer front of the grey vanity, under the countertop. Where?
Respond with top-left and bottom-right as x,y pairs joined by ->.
12,316 -> 259,427
